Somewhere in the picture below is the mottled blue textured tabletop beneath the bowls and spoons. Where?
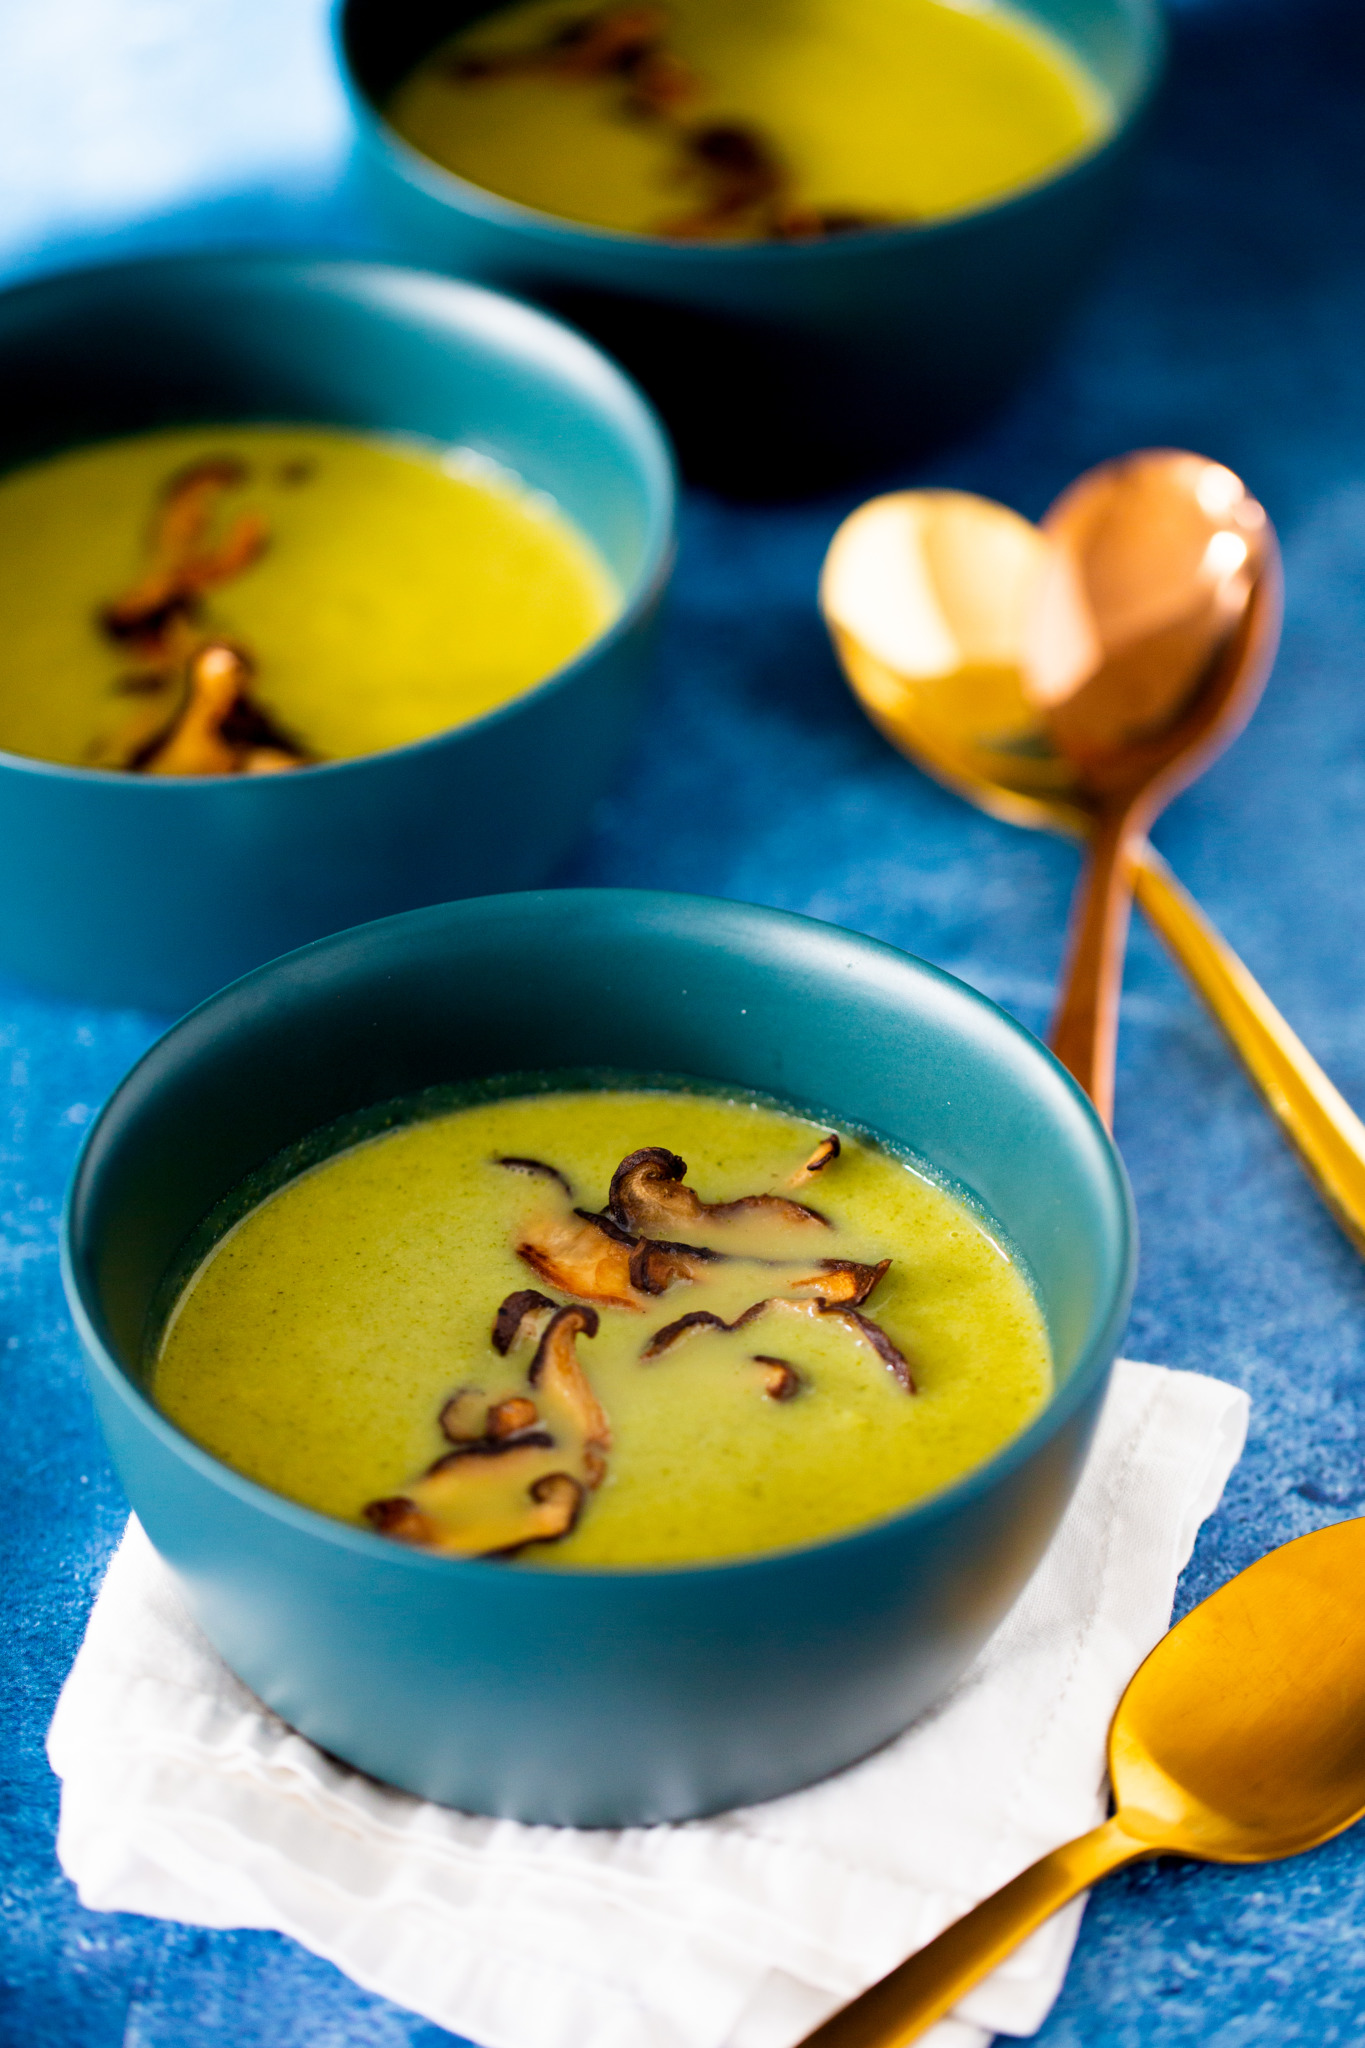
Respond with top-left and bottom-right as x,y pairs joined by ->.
0,0 -> 1365,2048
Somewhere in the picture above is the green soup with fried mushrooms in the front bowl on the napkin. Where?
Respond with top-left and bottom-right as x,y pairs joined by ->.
153,1087 -> 1052,1567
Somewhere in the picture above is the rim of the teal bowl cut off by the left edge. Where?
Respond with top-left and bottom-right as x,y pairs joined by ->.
0,246 -> 679,801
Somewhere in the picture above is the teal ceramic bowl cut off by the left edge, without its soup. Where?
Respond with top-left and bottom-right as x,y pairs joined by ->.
0,256 -> 673,1014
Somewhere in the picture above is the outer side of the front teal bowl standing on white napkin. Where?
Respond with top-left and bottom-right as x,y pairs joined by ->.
85,1351 -> 1103,1827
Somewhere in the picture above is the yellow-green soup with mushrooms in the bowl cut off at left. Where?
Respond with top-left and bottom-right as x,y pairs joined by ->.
0,426 -> 620,774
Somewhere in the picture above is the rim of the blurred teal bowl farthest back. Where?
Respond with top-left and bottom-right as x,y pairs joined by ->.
329,0 -> 1171,270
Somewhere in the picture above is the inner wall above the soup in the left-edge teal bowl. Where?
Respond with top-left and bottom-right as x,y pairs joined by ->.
0,256 -> 671,606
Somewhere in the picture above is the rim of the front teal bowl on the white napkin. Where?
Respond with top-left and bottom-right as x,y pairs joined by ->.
59,889 -> 1138,1583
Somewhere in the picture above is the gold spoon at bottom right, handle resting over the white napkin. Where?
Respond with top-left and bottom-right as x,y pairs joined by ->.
802,1522 -> 1365,2048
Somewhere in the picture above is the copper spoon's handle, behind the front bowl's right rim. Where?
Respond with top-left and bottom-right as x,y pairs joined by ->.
1048,805 -> 1140,1124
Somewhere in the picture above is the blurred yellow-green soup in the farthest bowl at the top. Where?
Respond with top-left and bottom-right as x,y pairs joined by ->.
385,0 -> 1113,240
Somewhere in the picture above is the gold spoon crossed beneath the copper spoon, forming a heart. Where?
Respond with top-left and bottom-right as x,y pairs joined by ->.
821,457 -> 1365,1196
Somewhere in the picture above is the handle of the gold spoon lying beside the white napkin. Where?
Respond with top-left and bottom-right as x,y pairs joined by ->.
789,1815 -> 1156,2048
